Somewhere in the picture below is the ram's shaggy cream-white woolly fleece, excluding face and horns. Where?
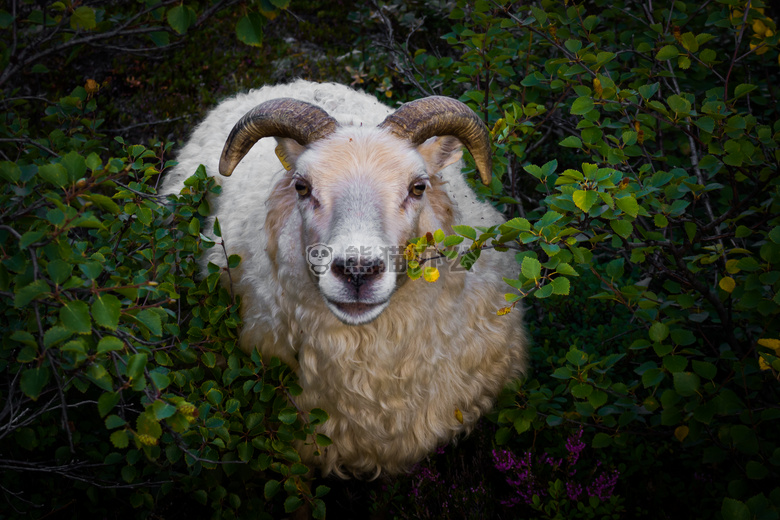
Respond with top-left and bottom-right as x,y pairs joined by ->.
161,81 -> 526,477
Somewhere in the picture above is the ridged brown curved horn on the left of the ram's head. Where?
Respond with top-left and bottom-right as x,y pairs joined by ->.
219,98 -> 338,177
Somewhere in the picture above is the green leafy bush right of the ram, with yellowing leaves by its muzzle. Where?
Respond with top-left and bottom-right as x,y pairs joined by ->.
362,1 -> 780,518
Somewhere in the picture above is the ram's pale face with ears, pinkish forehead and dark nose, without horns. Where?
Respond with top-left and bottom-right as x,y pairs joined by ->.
280,127 -> 460,325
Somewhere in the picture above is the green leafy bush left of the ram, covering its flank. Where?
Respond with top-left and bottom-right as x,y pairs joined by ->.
0,87 -> 329,518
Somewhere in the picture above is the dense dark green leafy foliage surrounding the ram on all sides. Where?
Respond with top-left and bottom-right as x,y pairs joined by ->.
0,0 -> 780,520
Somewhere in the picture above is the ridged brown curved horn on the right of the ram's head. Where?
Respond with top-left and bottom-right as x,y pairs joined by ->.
379,96 -> 493,186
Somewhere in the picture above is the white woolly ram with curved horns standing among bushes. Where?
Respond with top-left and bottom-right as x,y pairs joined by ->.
162,80 -> 526,477
